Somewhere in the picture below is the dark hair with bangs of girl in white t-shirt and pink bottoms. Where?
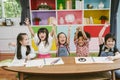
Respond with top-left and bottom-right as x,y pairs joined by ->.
37,28 -> 49,46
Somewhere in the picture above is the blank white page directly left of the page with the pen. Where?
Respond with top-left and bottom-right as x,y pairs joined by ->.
26,59 -> 44,67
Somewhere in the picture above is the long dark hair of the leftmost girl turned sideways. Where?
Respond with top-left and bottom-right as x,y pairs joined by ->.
17,33 -> 31,59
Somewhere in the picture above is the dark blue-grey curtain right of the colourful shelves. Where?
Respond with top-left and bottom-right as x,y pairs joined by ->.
110,0 -> 119,37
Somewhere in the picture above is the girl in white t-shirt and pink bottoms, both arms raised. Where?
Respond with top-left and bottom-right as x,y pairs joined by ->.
25,18 -> 54,58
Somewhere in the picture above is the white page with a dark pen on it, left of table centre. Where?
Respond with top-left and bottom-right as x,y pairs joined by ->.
44,57 -> 64,65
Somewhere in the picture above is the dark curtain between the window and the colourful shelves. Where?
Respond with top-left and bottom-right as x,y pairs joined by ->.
20,0 -> 30,25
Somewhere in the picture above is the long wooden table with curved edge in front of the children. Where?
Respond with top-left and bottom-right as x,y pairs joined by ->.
3,57 -> 120,80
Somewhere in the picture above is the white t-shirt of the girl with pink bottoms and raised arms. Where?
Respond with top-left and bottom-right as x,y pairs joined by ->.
34,34 -> 53,54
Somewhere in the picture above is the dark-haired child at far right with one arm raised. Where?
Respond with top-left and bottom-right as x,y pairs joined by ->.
98,23 -> 120,78
